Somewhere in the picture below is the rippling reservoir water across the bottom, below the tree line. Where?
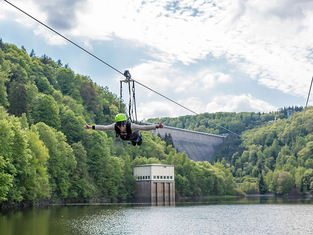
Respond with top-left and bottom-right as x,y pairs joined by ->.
0,198 -> 313,235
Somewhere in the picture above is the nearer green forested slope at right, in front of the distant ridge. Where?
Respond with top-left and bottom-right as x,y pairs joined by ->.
233,107 -> 313,194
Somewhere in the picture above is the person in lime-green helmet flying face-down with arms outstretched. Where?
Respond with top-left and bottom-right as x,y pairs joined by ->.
85,113 -> 163,146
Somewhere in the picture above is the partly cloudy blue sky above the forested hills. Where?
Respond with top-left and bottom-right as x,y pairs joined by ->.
0,0 -> 313,120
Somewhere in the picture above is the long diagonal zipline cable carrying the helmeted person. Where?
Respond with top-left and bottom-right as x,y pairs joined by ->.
4,0 -> 239,137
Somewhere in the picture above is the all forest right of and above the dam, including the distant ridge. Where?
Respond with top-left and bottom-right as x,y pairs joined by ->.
148,104 -> 313,195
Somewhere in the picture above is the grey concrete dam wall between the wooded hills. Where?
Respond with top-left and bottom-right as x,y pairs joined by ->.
151,126 -> 225,162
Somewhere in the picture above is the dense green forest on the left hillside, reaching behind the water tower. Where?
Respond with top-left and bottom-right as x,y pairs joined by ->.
0,39 -> 236,208
